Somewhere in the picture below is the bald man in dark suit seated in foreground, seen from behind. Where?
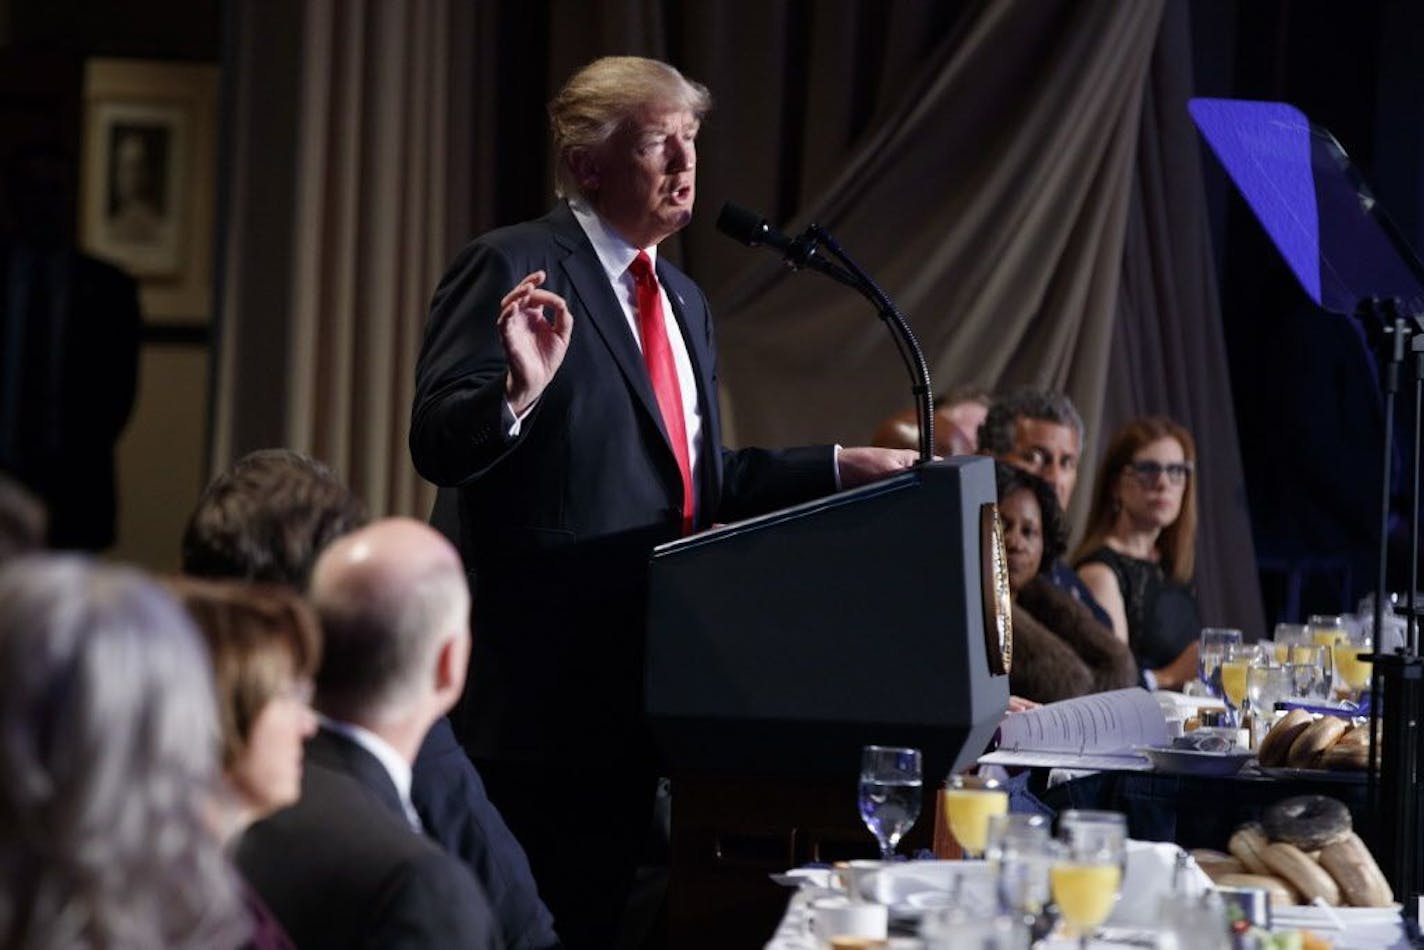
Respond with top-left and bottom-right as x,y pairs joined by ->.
236,518 -> 504,947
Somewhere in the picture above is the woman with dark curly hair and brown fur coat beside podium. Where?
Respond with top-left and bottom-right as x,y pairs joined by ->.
995,461 -> 1138,702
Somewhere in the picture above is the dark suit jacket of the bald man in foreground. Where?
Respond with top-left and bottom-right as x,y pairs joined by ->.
235,729 -> 504,950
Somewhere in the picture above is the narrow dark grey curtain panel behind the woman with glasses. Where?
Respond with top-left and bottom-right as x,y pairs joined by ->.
1099,3 -> 1269,632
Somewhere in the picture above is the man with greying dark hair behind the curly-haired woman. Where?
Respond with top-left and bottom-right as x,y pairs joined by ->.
978,387 -> 1112,630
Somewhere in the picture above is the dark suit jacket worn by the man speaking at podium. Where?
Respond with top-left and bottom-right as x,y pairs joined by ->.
410,205 -> 834,766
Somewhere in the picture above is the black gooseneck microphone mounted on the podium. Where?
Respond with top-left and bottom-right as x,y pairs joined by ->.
716,201 -> 934,461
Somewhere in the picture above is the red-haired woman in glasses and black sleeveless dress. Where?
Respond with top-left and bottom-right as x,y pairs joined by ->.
1072,416 -> 1202,689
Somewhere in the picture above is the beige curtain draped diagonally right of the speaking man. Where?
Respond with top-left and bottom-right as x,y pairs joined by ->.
709,0 -> 1162,464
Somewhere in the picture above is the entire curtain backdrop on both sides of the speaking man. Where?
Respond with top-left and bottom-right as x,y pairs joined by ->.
214,0 -> 1260,625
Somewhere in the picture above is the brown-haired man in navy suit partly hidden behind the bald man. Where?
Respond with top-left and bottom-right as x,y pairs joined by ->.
182,449 -> 558,950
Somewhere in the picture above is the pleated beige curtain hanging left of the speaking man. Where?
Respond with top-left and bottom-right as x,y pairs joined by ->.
214,0 -> 478,514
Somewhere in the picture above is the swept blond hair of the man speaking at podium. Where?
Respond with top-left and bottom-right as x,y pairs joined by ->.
548,56 -> 712,198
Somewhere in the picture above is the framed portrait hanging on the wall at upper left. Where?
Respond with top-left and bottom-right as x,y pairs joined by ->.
80,60 -> 216,323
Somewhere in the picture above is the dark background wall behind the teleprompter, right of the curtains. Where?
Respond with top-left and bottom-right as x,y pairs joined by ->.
1192,0 -> 1424,620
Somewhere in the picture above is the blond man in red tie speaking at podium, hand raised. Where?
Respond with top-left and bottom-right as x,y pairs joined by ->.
410,57 -> 916,949
